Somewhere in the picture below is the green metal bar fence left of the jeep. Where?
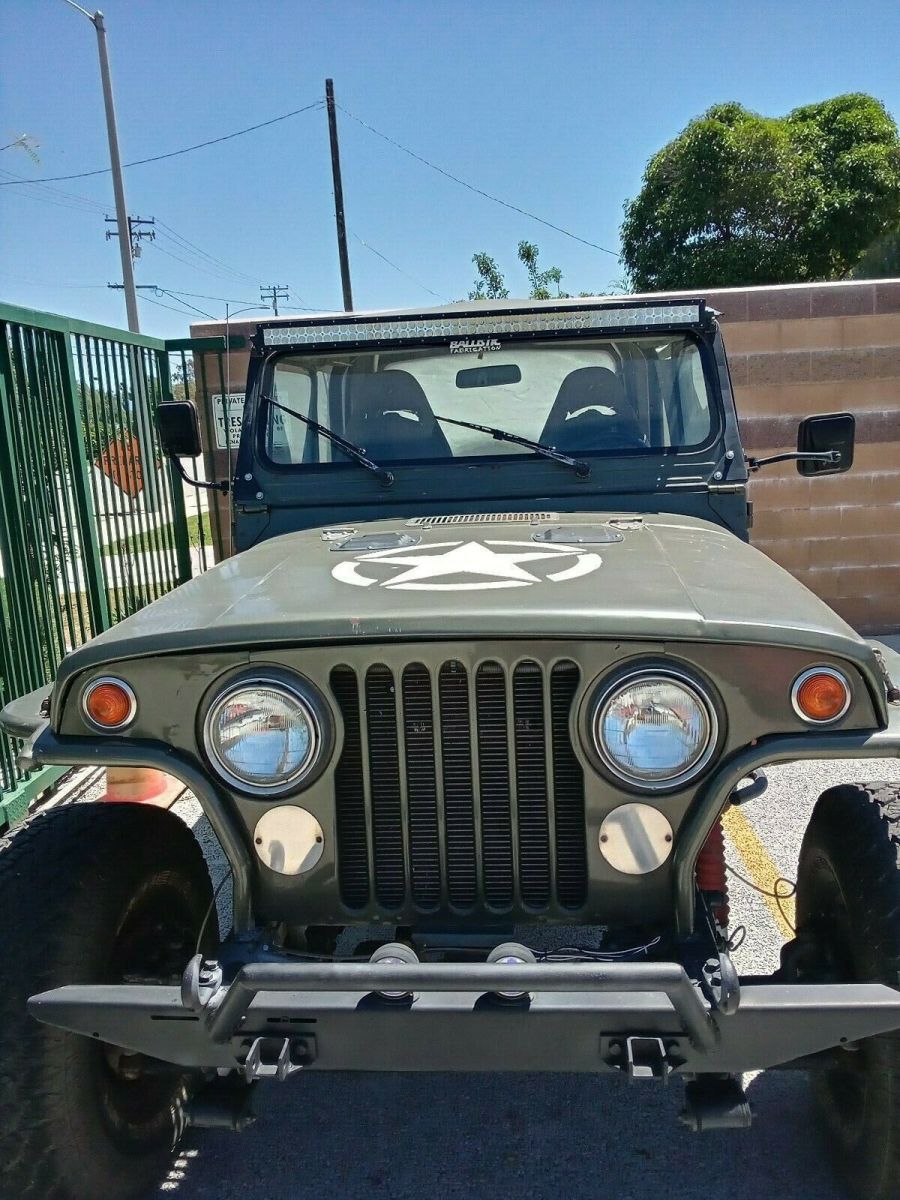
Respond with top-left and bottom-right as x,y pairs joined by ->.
0,305 -> 211,828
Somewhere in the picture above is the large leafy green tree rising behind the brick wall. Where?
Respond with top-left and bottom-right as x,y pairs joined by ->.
622,94 -> 900,290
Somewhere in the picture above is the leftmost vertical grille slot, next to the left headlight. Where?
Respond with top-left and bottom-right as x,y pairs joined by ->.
331,667 -> 368,908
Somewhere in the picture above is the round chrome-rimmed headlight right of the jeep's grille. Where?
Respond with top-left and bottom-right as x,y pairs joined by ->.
594,674 -> 718,788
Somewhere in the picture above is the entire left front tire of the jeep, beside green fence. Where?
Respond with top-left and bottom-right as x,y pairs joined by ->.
0,804 -> 218,1200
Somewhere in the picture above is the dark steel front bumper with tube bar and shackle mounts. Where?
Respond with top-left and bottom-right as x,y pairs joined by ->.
28,962 -> 900,1078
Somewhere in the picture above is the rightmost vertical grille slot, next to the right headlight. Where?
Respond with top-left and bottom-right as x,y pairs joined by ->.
550,662 -> 588,908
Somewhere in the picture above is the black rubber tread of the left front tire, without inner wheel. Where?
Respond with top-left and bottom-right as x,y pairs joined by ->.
0,804 -> 218,1200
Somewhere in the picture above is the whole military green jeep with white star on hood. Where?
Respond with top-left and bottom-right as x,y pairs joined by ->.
0,298 -> 900,1200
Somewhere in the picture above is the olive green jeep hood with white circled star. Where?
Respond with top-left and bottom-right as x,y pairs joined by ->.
60,512 -> 871,682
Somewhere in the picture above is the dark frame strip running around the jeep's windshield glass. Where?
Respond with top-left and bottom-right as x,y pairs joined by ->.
254,325 -> 725,481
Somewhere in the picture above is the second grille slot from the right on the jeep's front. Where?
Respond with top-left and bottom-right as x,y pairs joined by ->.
512,662 -> 550,908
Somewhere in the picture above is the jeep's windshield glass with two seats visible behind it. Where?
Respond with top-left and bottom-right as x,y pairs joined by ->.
259,335 -> 715,466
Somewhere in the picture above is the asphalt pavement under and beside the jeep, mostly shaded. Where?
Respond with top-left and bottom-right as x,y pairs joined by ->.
160,760 -> 900,1200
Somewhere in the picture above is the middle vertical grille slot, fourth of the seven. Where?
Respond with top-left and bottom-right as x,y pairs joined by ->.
438,661 -> 478,908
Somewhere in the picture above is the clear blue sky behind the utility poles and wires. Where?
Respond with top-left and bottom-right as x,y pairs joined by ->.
0,0 -> 900,336
